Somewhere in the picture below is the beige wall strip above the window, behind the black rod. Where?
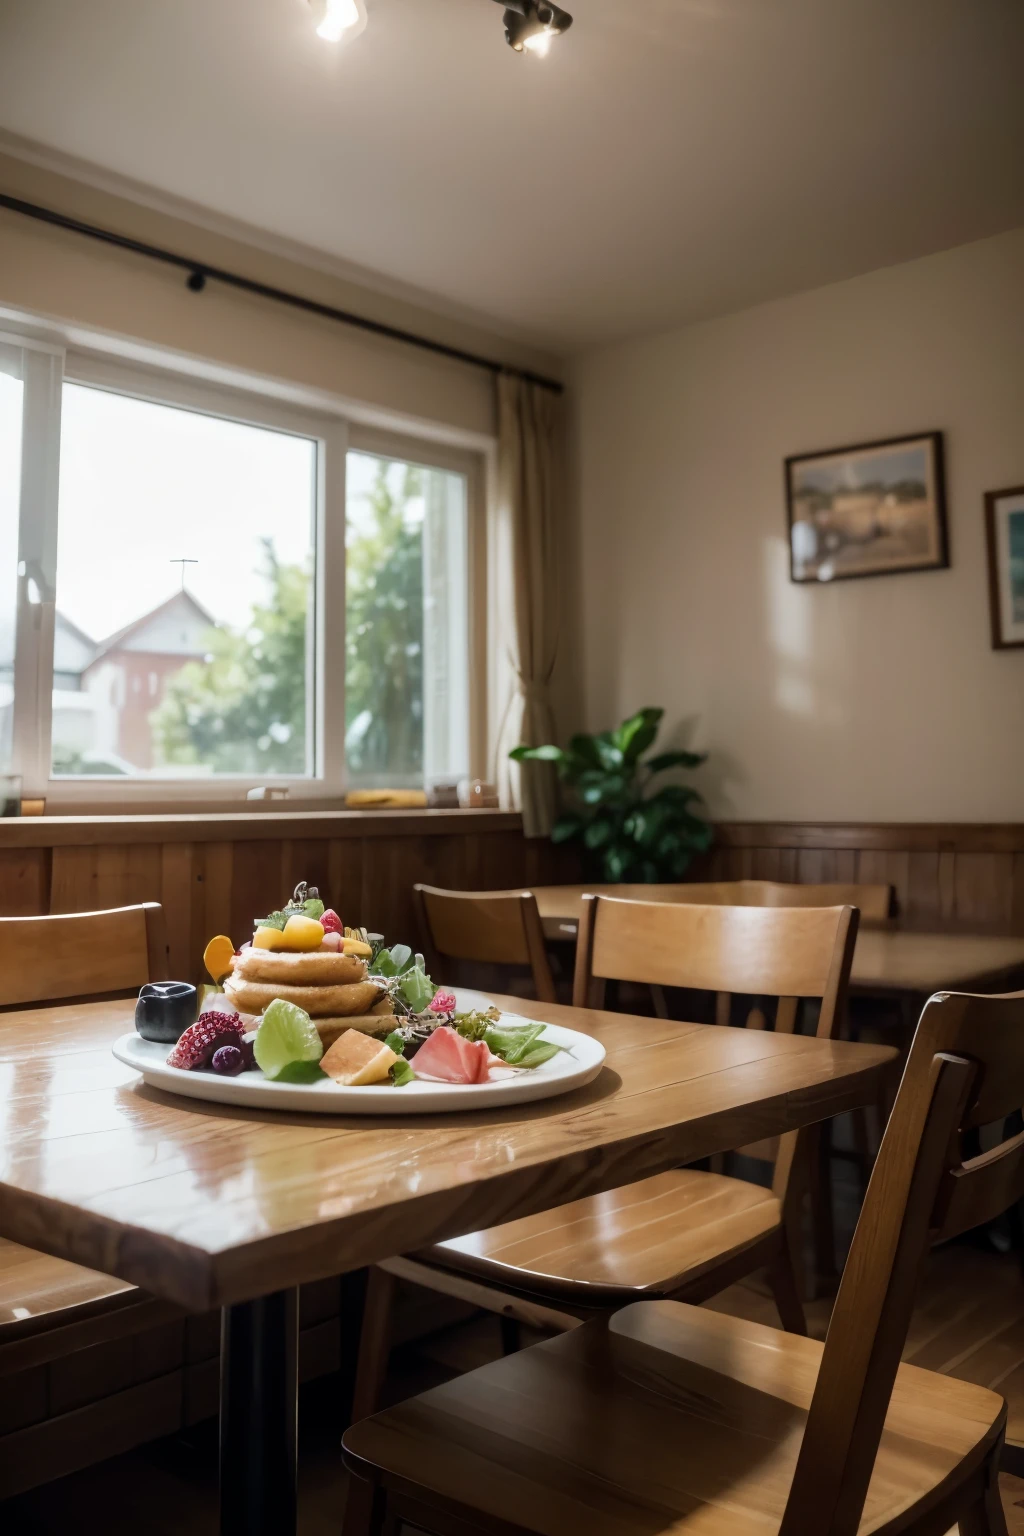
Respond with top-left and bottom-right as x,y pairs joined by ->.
0,152 -> 557,435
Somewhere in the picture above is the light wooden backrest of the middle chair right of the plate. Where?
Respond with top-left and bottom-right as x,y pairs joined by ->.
573,895 -> 858,1220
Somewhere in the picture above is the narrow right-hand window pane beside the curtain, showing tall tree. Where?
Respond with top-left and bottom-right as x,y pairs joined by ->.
345,453 -> 470,788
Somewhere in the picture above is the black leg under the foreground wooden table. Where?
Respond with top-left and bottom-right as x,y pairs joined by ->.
220,1290 -> 299,1536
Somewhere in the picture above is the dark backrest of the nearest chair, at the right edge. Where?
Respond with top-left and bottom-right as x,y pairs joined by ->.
780,992 -> 1024,1536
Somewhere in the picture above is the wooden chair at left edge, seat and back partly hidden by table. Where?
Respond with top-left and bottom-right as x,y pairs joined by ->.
0,902 -> 180,1376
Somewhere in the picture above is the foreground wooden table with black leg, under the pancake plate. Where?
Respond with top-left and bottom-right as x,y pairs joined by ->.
0,998 -> 894,1536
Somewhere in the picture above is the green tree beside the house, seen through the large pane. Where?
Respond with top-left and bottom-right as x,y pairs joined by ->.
150,539 -> 309,774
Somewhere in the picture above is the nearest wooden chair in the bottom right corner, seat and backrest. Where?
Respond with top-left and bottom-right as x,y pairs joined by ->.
344,992 -> 1024,1536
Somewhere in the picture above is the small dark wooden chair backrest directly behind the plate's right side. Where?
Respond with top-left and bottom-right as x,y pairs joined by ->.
413,885 -> 556,1003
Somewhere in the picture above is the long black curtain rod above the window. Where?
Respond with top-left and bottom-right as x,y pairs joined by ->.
0,192 -> 563,395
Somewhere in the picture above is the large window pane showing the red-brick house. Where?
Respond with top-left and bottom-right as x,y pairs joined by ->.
52,384 -> 316,779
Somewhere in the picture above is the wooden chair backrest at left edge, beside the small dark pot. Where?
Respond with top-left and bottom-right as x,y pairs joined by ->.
0,902 -> 167,1008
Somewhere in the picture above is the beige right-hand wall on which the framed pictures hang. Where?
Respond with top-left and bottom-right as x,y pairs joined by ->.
576,230 -> 1024,820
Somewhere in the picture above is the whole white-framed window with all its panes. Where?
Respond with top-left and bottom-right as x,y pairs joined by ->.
0,339 -> 482,806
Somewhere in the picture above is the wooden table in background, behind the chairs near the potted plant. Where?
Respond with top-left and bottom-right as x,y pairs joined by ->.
533,885 -> 1024,1000
